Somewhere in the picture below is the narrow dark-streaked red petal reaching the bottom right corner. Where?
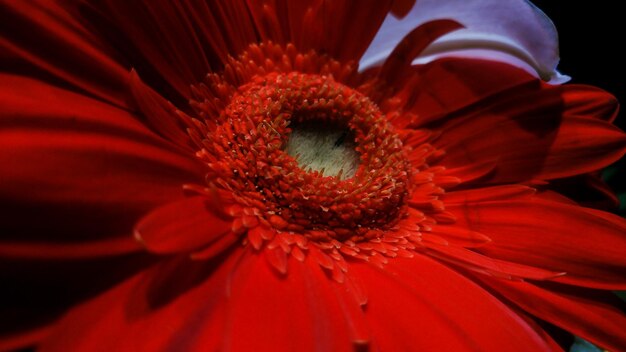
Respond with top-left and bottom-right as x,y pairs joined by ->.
482,278 -> 626,351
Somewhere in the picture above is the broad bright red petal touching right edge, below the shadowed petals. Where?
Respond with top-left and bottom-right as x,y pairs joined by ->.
447,198 -> 626,290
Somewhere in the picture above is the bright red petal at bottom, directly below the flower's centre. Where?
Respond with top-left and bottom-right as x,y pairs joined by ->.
223,254 -> 362,351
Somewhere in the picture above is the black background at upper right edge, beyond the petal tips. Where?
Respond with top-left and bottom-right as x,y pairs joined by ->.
532,0 -> 626,215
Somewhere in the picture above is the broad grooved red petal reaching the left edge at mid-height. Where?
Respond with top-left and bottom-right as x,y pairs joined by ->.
0,75 -> 204,240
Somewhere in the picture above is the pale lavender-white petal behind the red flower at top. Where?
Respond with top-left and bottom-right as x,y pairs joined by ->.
360,0 -> 567,83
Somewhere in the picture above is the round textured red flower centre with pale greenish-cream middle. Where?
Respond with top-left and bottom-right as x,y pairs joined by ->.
199,72 -> 410,240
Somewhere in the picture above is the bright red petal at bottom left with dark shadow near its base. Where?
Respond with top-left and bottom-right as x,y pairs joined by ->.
40,251 -> 249,351
